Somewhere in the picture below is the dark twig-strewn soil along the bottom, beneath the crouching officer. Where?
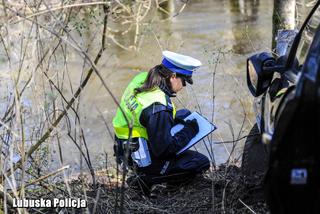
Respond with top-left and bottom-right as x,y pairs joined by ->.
25,165 -> 269,213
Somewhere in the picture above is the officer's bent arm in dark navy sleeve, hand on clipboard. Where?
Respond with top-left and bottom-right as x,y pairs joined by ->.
140,104 -> 195,157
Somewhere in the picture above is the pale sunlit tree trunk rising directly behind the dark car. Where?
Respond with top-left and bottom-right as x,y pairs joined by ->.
272,0 -> 296,49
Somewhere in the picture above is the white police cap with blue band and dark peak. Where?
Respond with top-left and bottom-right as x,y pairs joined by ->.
162,51 -> 202,77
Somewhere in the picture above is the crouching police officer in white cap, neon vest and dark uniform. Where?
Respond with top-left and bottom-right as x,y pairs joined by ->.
113,51 -> 210,195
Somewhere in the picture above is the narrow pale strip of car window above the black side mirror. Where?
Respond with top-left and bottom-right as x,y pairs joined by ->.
296,3 -> 320,73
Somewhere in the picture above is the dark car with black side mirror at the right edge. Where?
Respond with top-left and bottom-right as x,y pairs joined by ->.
242,1 -> 320,213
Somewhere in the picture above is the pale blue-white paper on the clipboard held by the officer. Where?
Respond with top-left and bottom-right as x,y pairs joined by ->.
171,112 -> 217,155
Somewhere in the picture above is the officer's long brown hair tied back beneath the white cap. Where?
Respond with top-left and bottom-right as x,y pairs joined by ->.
134,64 -> 173,95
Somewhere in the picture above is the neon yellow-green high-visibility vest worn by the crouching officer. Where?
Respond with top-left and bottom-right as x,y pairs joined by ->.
112,72 -> 176,139
